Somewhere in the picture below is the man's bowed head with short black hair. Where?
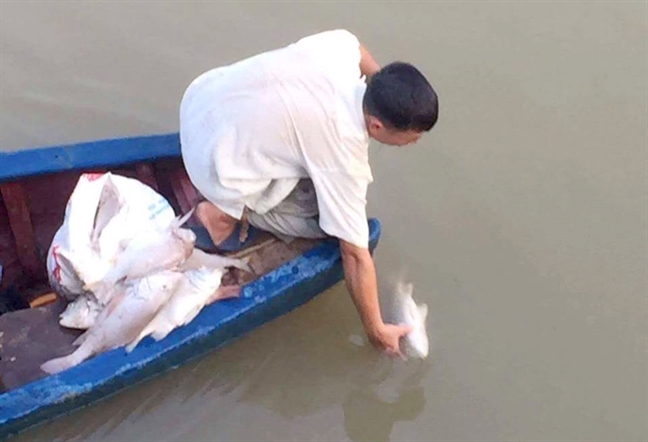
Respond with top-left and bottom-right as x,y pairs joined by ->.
363,62 -> 439,146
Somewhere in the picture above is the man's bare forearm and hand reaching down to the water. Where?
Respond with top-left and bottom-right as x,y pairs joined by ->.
340,240 -> 411,355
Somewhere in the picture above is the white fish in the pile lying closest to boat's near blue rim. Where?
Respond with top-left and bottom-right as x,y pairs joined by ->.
126,267 -> 240,352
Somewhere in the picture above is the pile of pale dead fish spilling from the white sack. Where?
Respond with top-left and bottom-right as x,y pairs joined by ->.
41,174 -> 249,374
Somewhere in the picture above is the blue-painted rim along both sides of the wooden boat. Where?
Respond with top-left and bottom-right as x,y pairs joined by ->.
0,134 -> 381,439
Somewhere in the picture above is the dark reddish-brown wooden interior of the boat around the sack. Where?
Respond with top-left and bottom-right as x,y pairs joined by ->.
0,158 -> 321,392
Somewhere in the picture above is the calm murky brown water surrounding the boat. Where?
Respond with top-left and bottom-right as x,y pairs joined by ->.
0,0 -> 648,441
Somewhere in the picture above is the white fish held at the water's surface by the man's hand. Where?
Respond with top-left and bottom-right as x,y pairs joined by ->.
394,283 -> 430,359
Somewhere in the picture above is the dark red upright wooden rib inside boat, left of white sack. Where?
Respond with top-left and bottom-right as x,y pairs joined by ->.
0,183 -> 44,279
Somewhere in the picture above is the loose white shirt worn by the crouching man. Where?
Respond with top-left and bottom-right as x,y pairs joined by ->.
180,30 -> 373,247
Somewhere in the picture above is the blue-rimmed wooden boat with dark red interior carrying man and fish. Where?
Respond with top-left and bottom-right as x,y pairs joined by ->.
0,133 -> 380,439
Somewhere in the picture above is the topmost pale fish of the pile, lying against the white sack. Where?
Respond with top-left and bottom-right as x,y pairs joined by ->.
86,210 -> 196,290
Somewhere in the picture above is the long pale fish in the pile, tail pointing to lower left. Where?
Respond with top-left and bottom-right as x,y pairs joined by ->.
41,271 -> 182,374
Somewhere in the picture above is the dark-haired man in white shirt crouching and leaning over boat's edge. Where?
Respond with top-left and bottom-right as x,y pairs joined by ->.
180,30 -> 438,355
